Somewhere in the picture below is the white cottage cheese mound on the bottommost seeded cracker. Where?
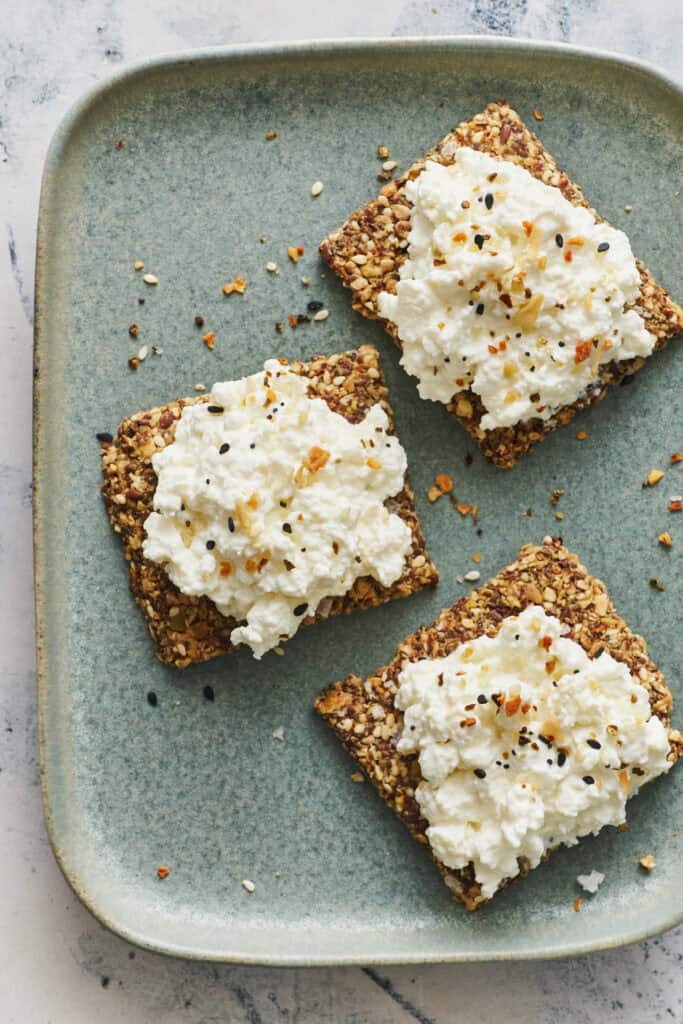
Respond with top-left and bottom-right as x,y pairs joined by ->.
395,605 -> 671,897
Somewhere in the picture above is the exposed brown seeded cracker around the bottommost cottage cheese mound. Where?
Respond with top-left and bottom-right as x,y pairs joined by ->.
314,538 -> 683,910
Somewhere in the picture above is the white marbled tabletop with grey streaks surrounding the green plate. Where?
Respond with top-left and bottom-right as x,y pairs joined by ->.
0,0 -> 683,1024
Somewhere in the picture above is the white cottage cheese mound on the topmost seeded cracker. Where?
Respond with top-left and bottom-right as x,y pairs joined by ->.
379,147 -> 655,430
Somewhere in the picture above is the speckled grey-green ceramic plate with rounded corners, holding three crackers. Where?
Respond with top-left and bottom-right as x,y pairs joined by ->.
35,39 -> 683,965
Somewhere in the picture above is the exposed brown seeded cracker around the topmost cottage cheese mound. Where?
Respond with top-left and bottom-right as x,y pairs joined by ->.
321,102 -> 683,469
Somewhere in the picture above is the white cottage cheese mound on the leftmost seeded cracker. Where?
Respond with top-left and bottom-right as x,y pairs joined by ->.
142,359 -> 412,658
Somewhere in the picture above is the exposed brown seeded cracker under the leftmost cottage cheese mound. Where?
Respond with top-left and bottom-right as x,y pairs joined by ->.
101,345 -> 438,669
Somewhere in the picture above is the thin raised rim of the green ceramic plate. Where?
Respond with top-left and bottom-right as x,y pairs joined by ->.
33,35 -> 683,968
